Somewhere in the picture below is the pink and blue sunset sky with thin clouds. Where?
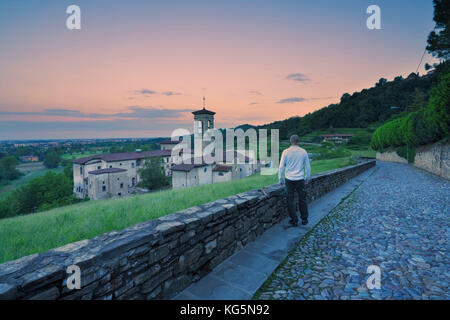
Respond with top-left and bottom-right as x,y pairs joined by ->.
0,0 -> 435,140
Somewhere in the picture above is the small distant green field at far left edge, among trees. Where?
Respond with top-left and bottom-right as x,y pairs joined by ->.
0,162 -> 63,200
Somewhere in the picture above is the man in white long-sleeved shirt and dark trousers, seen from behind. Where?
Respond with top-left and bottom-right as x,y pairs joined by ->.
278,134 -> 311,227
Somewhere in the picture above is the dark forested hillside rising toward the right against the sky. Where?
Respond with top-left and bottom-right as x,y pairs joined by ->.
259,62 -> 449,139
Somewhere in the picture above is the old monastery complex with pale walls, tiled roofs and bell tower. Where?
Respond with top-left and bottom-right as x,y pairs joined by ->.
72,107 -> 260,200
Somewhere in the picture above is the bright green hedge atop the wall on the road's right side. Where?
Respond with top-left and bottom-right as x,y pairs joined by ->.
370,73 -> 450,151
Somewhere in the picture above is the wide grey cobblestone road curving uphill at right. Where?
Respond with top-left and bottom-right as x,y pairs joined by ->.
255,162 -> 450,300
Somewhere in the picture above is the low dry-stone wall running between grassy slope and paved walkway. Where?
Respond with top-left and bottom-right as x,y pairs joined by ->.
0,160 -> 375,299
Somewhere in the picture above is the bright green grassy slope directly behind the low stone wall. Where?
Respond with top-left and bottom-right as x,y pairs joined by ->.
0,158 -> 353,263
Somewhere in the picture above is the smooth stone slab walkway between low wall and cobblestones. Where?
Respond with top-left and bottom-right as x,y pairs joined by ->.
174,167 -> 376,300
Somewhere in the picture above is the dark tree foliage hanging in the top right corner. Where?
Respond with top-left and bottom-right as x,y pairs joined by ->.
427,0 -> 450,60
